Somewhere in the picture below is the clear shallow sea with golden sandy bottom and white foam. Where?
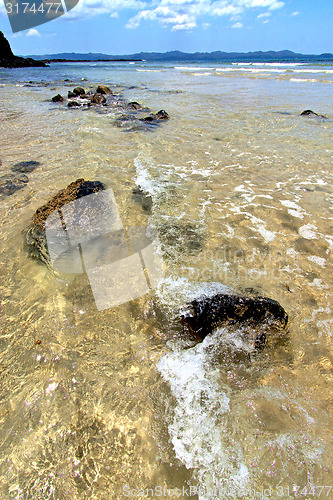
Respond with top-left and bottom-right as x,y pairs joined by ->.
0,61 -> 333,500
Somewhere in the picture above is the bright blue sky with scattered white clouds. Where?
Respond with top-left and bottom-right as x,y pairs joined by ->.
0,0 -> 333,55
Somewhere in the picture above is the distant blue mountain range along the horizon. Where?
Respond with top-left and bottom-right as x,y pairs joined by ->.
29,50 -> 333,62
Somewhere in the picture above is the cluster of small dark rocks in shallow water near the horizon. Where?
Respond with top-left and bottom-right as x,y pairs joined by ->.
52,85 -> 169,130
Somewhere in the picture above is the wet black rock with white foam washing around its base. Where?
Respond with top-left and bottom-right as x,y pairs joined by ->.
182,294 -> 288,345
